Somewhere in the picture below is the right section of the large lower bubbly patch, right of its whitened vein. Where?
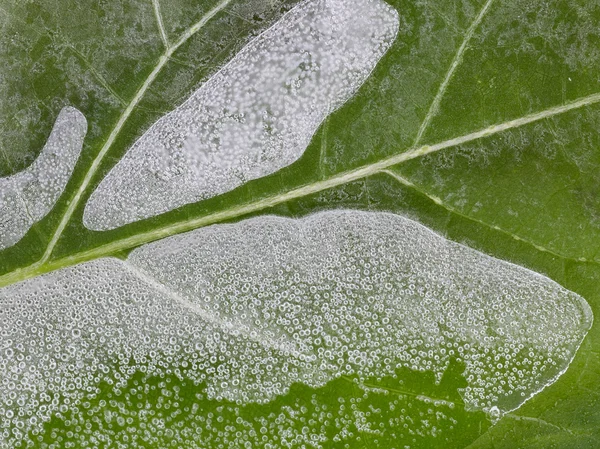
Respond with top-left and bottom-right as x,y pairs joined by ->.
129,211 -> 592,411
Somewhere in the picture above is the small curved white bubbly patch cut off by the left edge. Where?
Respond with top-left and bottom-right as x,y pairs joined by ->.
0,107 -> 87,249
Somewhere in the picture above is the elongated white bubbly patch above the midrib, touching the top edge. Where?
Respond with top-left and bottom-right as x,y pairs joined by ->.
83,0 -> 398,230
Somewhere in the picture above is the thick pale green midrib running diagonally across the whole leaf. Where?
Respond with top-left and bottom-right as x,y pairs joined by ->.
0,93 -> 600,287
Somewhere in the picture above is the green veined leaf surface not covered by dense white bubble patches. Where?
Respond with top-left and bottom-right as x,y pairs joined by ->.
0,0 -> 600,448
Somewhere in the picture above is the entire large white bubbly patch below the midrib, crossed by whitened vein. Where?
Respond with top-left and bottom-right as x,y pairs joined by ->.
0,211 -> 592,447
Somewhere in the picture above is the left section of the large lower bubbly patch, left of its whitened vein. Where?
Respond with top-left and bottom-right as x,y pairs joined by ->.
0,258 -> 327,449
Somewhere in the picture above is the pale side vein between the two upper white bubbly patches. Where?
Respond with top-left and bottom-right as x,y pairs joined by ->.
34,0 -> 231,266
